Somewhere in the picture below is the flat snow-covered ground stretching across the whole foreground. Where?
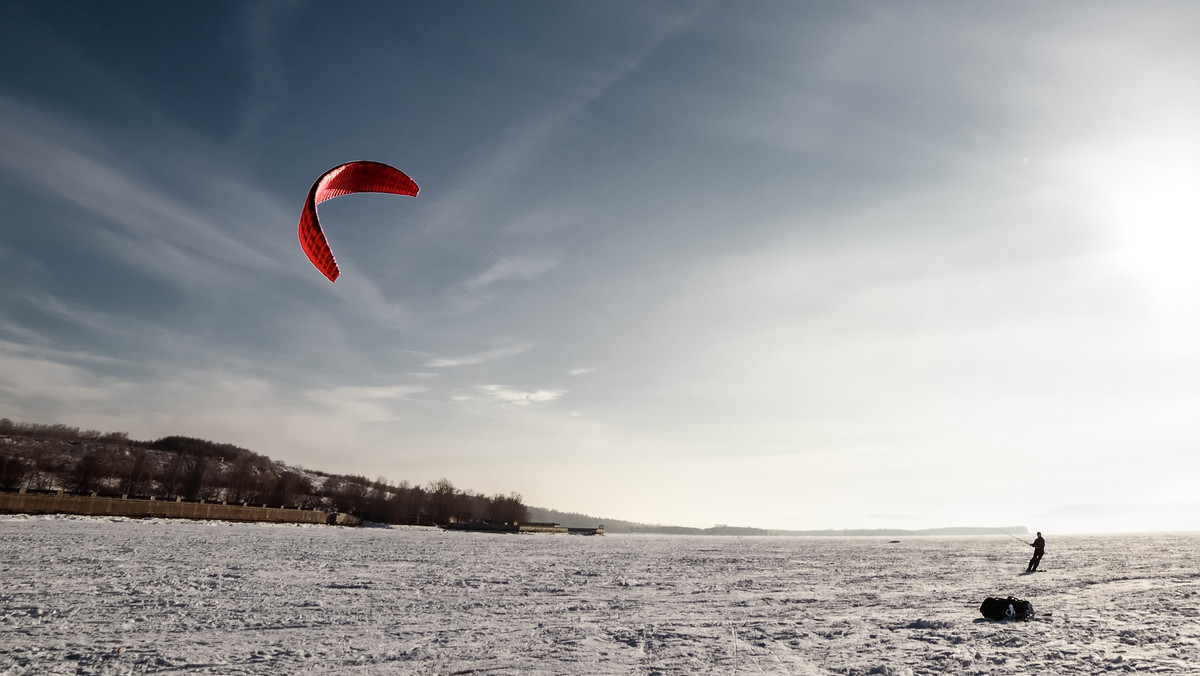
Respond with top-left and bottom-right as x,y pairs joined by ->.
0,516 -> 1200,675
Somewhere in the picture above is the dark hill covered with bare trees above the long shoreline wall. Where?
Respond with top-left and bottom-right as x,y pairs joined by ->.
0,418 -> 529,525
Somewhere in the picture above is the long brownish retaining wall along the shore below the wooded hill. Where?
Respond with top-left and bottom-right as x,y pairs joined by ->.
0,492 -> 360,526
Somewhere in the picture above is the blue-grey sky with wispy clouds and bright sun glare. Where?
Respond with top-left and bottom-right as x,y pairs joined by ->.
0,0 -> 1200,536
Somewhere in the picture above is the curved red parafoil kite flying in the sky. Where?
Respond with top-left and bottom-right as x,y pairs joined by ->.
299,162 -> 420,282
